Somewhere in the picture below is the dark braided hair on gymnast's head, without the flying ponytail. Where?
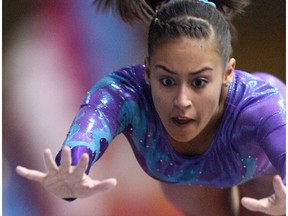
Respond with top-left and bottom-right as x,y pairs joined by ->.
148,0 -> 232,63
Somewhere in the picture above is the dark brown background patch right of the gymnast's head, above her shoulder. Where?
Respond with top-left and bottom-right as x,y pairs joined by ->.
234,0 -> 286,81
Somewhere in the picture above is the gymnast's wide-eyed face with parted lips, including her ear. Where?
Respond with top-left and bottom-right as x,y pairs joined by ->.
145,37 -> 235,148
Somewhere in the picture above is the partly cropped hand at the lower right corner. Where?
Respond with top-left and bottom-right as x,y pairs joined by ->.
241,175 -> 286,215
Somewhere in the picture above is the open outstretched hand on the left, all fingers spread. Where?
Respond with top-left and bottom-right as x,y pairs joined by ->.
16,147 -> 117,198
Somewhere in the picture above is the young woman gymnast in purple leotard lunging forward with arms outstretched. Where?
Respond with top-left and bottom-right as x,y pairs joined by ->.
17,0 -> 286,216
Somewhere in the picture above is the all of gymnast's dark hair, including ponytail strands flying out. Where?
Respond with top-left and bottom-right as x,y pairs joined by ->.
93,0 -> 250,61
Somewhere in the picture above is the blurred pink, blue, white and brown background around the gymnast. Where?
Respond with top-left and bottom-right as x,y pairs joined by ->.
2,0 -> 286,216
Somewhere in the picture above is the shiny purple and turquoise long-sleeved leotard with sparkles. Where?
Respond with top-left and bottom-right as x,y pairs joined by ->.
56,65 -> 286,188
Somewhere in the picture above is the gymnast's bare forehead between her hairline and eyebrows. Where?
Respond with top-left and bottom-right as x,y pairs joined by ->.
150,37 -> 222,75
